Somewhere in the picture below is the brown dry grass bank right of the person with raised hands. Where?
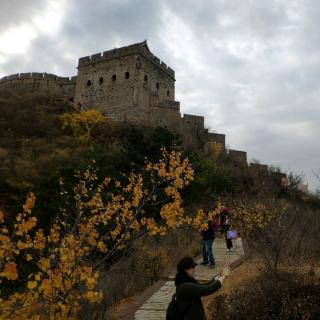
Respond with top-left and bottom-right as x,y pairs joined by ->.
204,259 -> 320,320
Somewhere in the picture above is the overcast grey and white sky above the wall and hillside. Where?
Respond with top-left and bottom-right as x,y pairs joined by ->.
0,0 -> 320,190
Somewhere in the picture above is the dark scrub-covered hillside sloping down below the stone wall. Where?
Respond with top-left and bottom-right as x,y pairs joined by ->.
0,92 -> 320,319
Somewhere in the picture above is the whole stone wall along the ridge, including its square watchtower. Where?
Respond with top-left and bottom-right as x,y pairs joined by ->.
0,41 -> 286,179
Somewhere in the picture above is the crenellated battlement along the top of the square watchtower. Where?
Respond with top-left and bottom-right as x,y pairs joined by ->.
78,41 -> 175,79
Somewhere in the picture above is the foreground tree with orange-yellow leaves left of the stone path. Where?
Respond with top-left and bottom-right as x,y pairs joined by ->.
0,150 -> 212,319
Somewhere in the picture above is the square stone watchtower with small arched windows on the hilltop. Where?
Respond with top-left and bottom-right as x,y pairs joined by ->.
75,42 -> 176,125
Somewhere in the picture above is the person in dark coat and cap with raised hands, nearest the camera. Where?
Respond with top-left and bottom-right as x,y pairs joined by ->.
175,256 -> 230,320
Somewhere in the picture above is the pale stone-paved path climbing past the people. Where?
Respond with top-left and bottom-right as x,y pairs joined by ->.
134,238 -> 244,320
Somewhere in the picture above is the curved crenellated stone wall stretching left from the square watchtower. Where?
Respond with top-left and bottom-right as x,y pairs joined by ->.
0,72 -> 77,99
